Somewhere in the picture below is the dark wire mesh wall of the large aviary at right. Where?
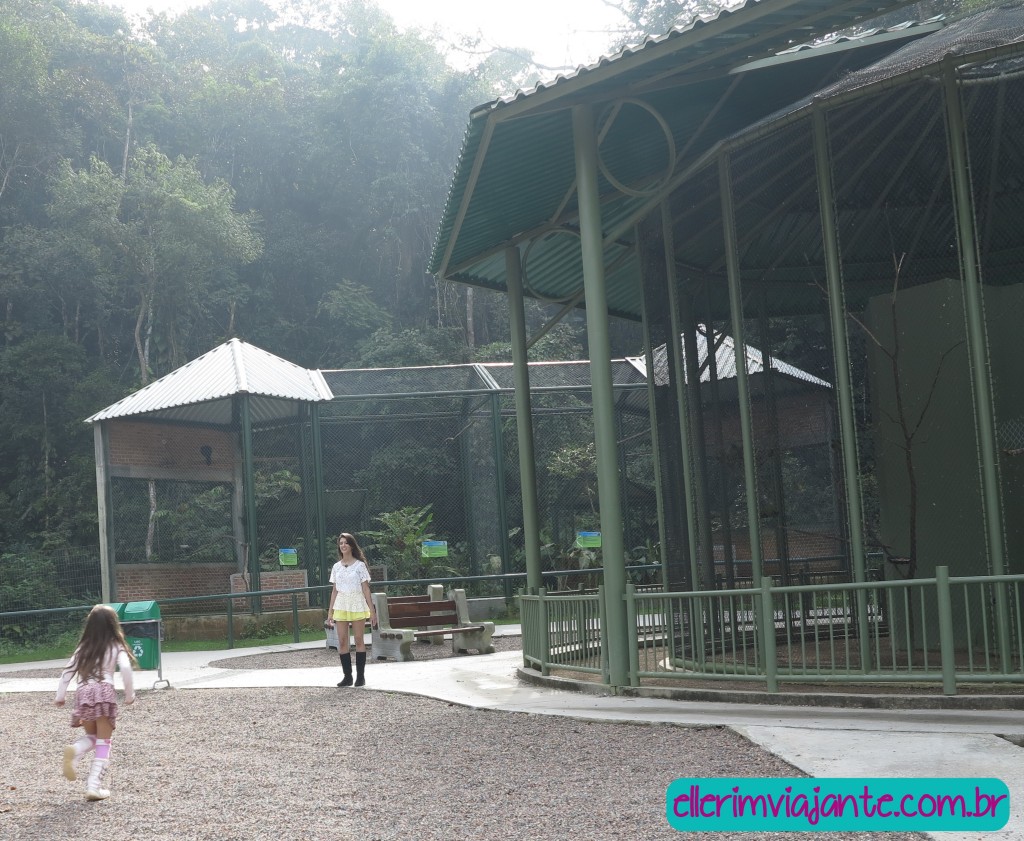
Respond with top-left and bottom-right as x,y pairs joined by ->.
638,26 -> 1024,680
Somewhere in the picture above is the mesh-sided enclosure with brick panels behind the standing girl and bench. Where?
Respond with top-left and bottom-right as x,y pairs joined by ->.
74,360 -> 657,614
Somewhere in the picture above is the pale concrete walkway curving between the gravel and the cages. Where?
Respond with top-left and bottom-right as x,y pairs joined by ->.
0,628 -> 1024,841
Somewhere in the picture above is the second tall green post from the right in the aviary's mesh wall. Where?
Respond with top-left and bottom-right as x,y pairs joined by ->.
813,110 -> 870,670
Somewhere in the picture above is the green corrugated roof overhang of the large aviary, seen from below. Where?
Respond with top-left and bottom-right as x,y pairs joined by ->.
430,0 -> 934,318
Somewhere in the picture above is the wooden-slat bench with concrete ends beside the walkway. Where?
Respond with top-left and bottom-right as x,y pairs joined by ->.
371,584 -> 495,661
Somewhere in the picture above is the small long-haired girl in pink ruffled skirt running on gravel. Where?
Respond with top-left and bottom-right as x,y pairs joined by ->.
53,604 -> 138,800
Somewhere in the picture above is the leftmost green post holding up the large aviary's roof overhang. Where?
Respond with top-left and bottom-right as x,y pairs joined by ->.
505,248 -> 543,593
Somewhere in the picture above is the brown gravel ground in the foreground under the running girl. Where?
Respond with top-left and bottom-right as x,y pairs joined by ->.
0,640 -> 921,841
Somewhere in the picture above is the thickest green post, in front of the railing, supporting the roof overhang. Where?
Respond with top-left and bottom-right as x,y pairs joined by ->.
572,106 -> 629,686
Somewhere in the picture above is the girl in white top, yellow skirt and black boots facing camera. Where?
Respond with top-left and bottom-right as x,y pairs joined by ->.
327,532 -> 377,686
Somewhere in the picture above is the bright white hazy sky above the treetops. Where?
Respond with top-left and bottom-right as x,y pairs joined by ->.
106,0 -> 621,68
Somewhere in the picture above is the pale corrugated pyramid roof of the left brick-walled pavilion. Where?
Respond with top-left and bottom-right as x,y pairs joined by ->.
86,339 -> 333,424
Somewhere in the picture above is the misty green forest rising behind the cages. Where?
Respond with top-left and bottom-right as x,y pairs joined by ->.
0,0 -> 974,609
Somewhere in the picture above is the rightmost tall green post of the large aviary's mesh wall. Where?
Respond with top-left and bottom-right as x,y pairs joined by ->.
942,62 -> 1013,674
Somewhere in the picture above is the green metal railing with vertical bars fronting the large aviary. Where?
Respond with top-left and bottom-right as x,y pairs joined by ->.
520,566 -> 1024,695
